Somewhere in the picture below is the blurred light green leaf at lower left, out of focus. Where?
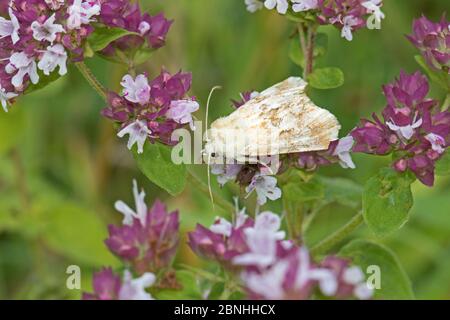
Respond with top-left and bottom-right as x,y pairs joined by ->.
43,203 -> 117,267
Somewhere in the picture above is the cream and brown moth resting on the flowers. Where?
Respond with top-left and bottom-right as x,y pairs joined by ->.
204,77 -> 341,163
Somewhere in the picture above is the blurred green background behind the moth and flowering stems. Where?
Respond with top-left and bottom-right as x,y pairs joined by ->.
0,0 -> 450,299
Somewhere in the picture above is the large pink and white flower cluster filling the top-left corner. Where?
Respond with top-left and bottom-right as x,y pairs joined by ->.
0,0 -> 101,111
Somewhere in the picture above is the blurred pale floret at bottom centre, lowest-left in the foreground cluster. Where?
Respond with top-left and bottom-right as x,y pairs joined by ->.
242,260 -> 289,300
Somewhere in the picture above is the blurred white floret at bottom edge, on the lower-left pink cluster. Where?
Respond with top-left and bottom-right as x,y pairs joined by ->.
119,270 -> 156,300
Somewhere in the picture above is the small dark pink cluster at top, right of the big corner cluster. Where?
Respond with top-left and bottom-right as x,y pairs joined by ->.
99,0 -> 172,56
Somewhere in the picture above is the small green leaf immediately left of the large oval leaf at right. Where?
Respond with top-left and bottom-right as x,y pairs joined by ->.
319,177 -> 363,209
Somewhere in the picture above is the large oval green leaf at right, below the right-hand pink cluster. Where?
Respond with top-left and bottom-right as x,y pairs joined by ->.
362,168 -> 413,237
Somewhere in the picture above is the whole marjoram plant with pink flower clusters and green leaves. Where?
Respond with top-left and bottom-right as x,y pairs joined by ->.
0,0 -> 450,300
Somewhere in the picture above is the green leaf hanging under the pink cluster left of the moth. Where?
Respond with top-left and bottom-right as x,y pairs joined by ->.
134,142 -> 187,196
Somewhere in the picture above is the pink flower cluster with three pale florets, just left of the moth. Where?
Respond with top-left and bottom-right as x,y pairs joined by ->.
102,70 -> 200,153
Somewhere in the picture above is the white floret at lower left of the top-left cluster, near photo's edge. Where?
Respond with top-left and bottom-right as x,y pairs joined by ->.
5,52 -> 39,88
